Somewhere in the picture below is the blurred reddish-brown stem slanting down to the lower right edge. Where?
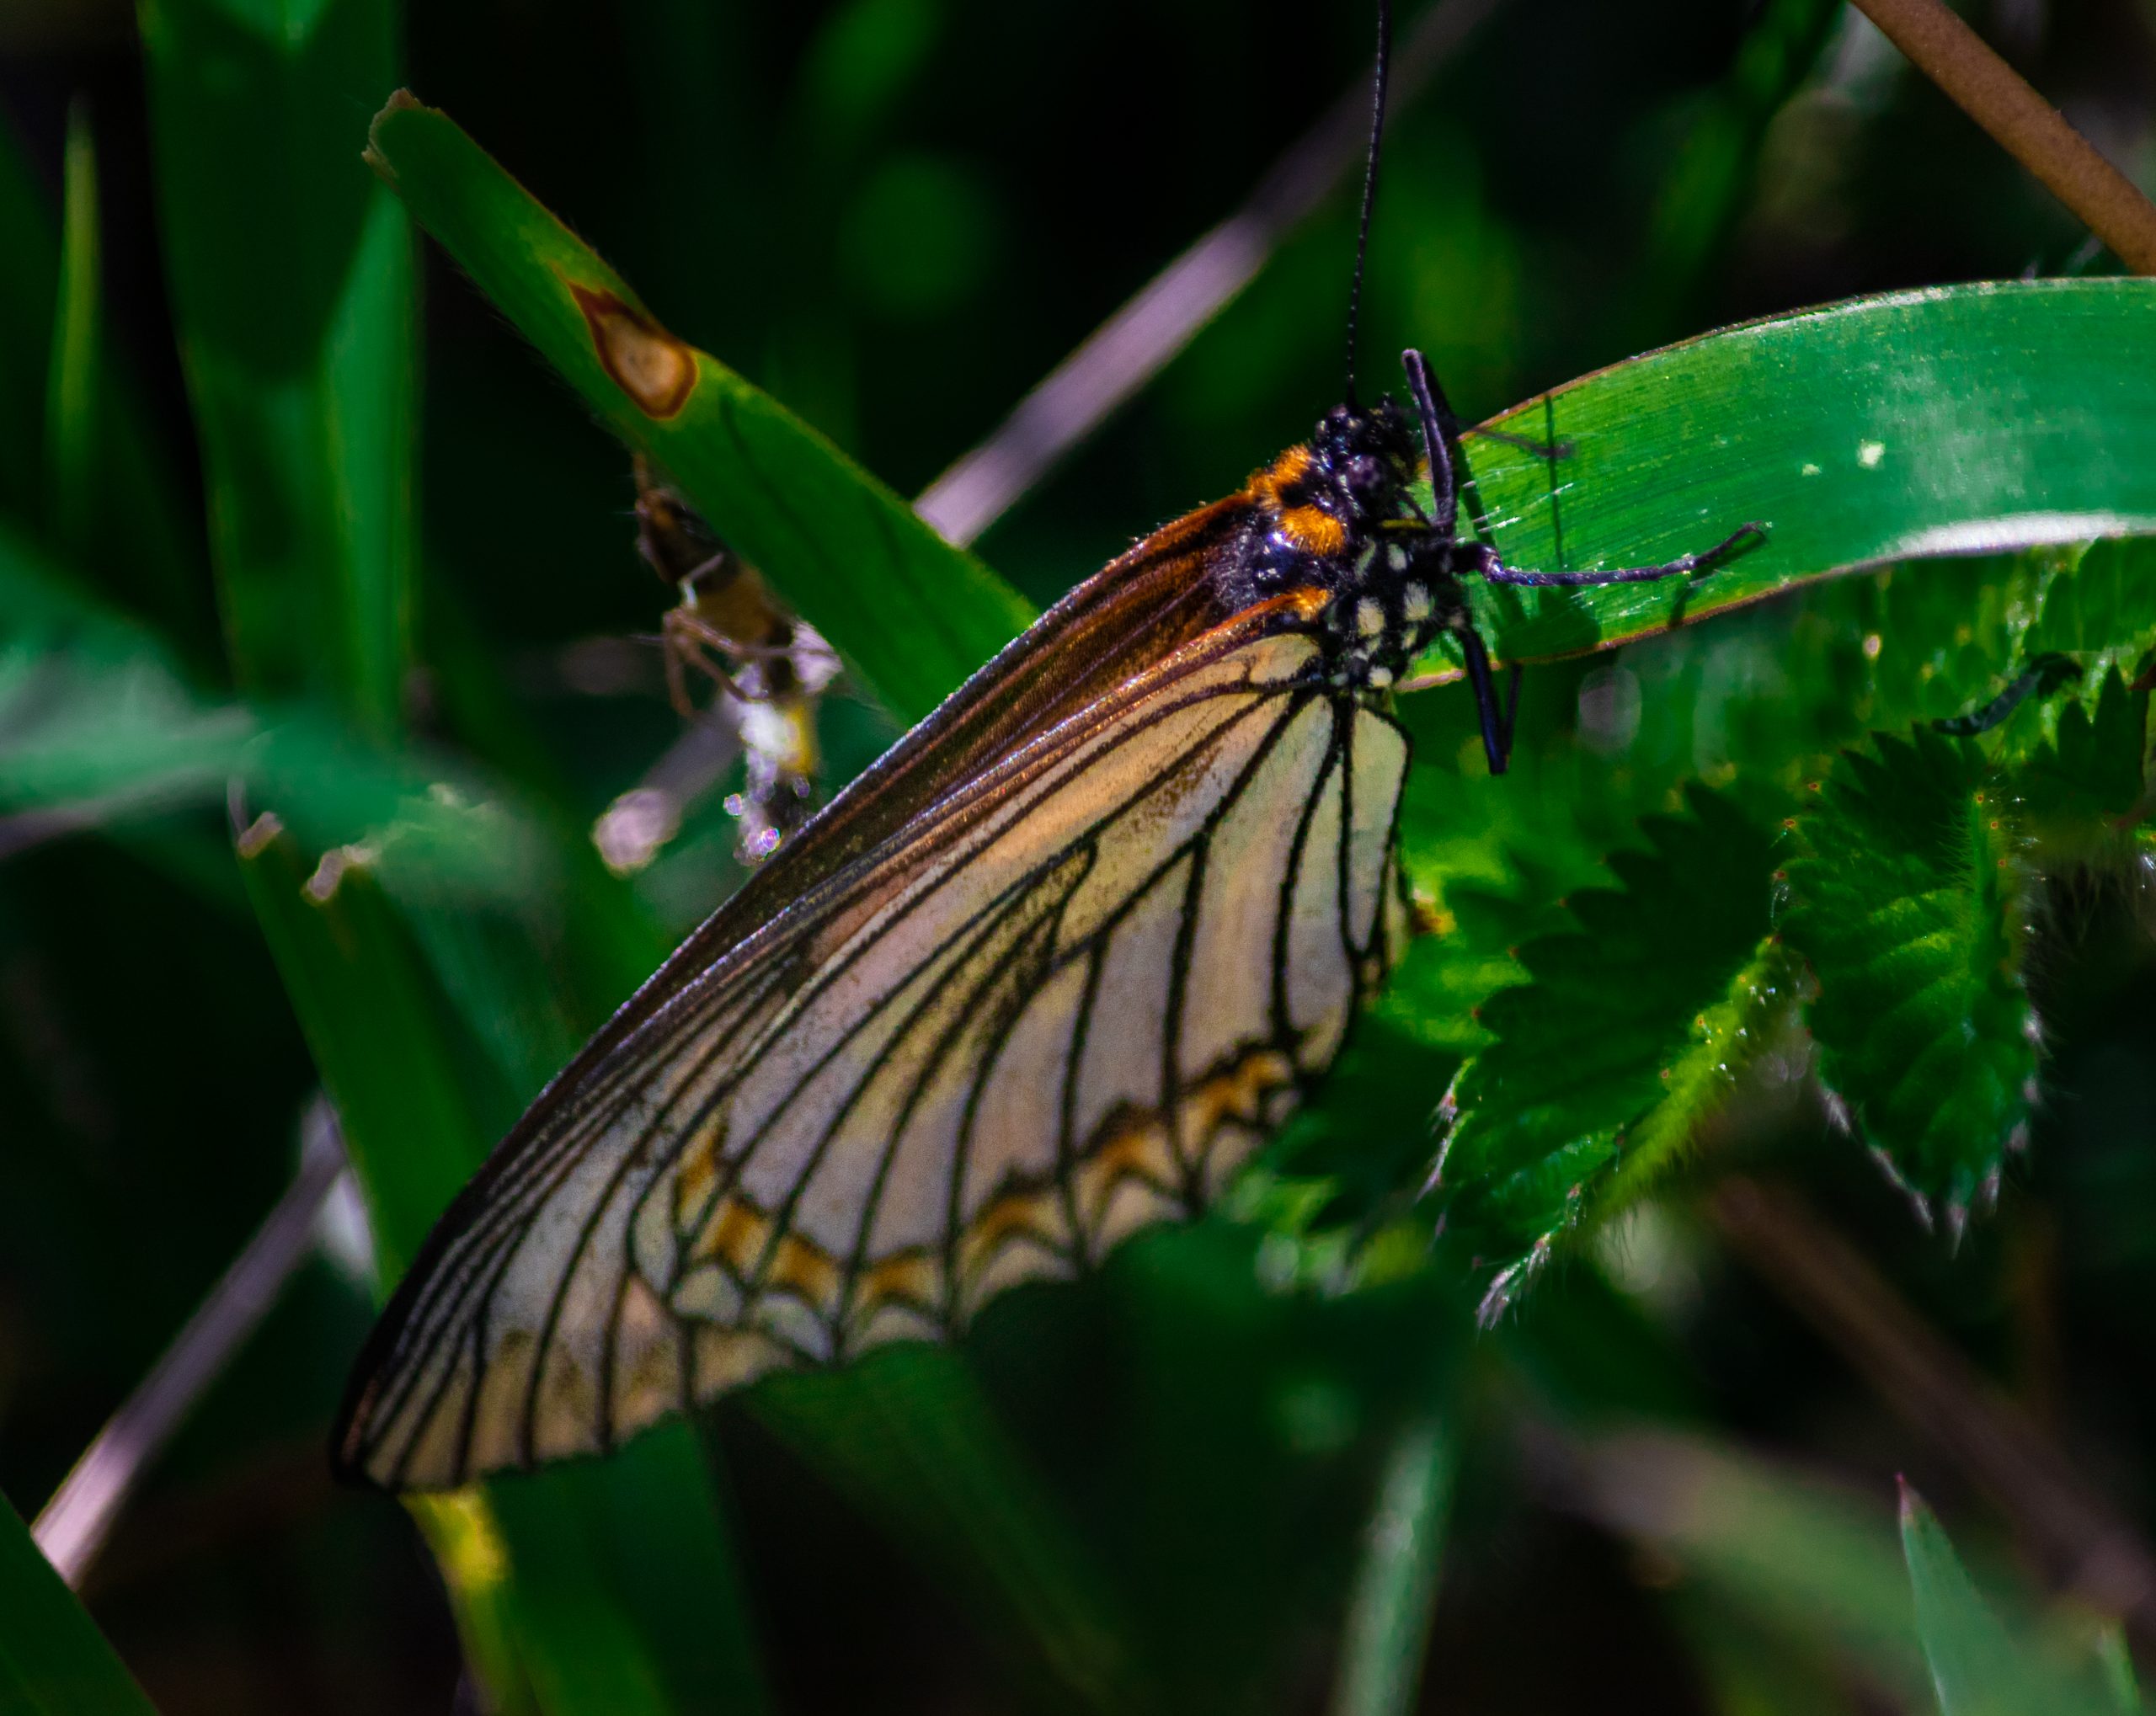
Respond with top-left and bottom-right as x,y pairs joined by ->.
1708,1179 -> 2156,1649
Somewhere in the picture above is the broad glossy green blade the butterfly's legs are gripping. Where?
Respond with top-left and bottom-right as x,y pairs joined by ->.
1432,280 -> 2156,666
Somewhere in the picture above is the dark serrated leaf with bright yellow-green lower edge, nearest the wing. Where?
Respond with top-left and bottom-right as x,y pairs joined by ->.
1438,787 -> 1790,1317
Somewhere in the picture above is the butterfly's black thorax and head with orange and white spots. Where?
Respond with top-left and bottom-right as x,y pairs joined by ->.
1216,399 -> 1466,692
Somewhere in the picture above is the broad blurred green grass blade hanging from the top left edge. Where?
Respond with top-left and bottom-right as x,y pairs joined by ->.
140,0 -> 416,735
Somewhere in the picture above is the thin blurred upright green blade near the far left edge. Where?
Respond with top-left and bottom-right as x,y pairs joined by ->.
45,97 -> 101,562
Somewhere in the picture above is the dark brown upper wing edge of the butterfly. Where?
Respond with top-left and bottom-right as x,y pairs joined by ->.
330,496 -> 1251,1483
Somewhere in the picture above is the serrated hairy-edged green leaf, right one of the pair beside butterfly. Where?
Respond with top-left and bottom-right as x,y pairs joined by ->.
1781,728 -> 2036,1231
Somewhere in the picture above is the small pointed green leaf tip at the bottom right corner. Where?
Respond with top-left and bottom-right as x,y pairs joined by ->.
1902,1481 -> 2115,1716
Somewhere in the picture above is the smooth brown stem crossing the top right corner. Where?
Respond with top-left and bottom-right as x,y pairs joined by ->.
1854,0 -> 2156,274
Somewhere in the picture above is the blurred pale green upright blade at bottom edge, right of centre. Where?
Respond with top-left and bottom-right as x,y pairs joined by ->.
1332,1412 -> 1458,1716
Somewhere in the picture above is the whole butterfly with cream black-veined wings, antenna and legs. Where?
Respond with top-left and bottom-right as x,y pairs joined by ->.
334,8 -> 1762,1490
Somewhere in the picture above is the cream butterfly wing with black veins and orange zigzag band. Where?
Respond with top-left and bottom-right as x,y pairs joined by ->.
339,623 -> 1408,1488
